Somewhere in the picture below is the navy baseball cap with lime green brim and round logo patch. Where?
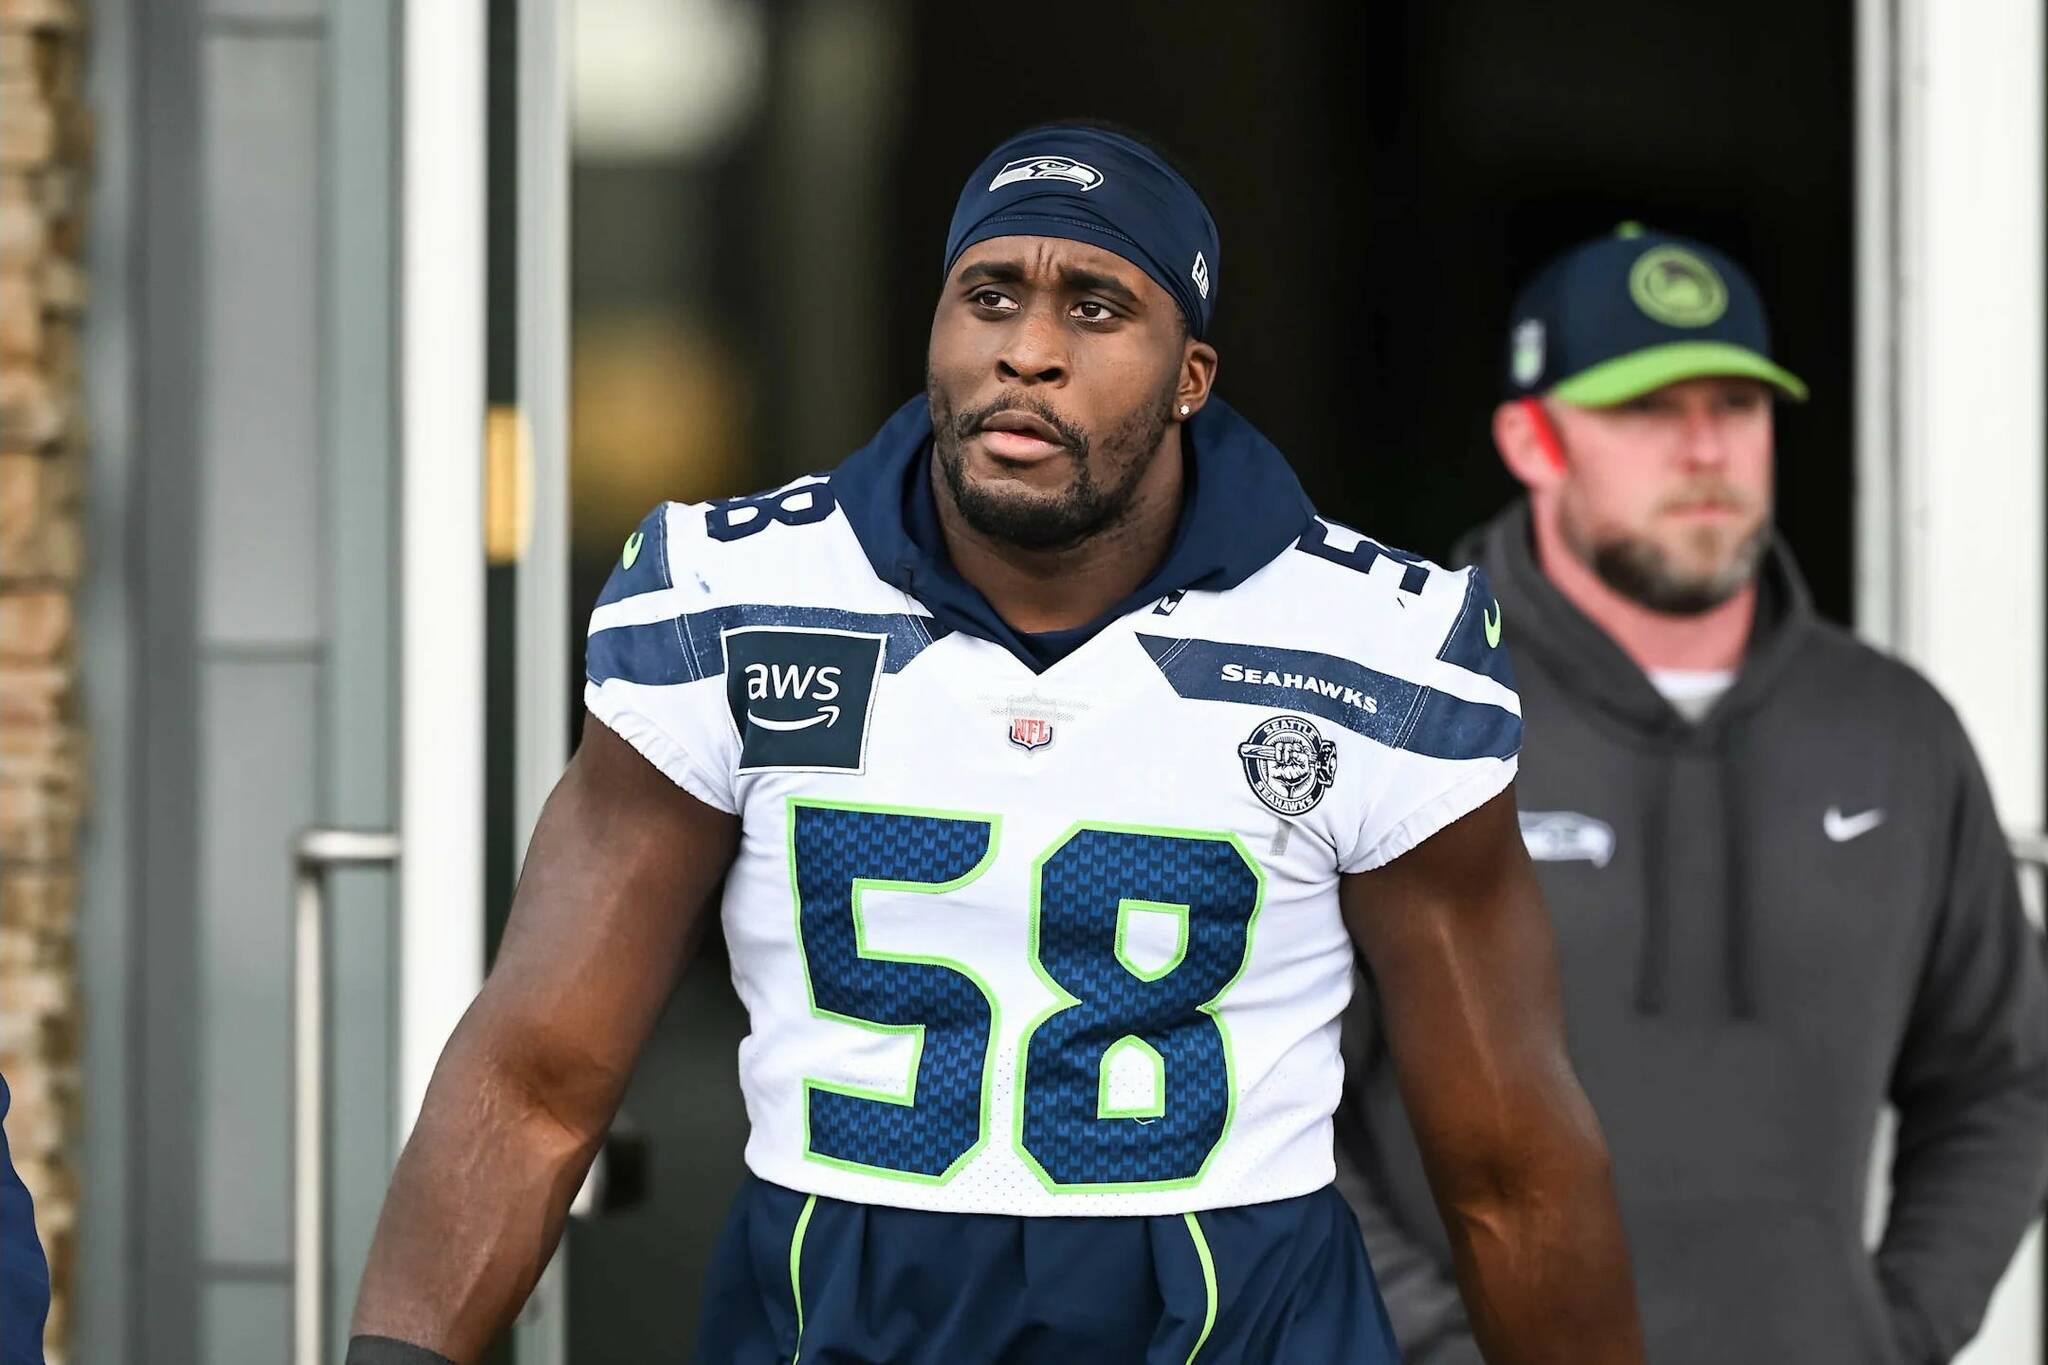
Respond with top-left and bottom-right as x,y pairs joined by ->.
1507,223 -> 1806,407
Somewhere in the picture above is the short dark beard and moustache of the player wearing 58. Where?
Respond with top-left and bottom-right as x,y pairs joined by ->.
926,375 -> 1178,551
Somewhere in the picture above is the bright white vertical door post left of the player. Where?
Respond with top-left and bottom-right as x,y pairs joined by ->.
393,0 -> 487,1150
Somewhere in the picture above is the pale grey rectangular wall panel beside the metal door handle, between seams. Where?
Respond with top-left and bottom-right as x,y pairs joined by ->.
199,659 -> 317,1263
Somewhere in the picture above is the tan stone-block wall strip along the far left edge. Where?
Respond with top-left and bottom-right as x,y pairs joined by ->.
0,0 -> 90,1363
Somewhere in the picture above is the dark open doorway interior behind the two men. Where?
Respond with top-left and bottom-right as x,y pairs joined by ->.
569,0 -> 1853,1365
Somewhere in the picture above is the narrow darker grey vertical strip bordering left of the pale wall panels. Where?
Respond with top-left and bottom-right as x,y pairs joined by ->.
134,0 -> 205,1365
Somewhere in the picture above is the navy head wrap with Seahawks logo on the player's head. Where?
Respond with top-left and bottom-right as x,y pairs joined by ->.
944,123 -> 1219,336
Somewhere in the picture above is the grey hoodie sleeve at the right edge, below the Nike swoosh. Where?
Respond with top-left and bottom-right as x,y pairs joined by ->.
1876,716 -> 2048,1365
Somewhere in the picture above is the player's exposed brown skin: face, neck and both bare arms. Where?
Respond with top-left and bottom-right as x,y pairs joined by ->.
352,237 -> 1642,1365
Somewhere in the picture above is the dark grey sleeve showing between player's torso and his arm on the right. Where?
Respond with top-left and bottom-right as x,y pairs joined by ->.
1335,994 -> 1481,1365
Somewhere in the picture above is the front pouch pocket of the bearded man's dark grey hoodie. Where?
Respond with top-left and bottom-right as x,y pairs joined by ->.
1626,1197 -> 1905,1365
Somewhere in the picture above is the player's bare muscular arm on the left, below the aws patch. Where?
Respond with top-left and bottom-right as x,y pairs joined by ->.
352,720 -> 739,1361
